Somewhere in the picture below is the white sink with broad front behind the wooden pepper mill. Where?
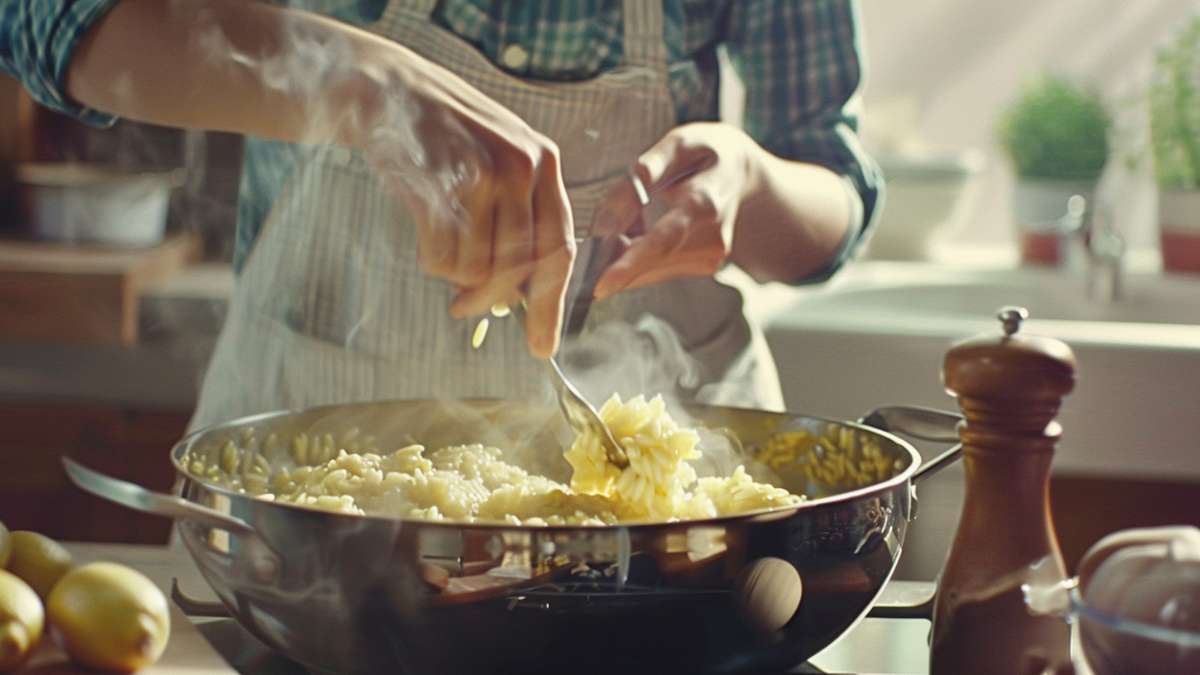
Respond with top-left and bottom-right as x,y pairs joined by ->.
750,262 -> 1200,480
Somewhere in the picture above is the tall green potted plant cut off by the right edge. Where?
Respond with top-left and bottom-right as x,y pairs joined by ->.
1150,17 -> 1200,271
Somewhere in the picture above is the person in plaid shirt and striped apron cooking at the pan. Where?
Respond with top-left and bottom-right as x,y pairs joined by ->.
0,0 -> 882,425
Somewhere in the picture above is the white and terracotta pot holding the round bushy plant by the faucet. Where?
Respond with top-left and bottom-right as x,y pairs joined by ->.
1013,178 -> 1096,265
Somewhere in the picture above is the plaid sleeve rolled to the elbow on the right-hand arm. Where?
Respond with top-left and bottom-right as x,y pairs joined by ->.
726,0 -> 883,281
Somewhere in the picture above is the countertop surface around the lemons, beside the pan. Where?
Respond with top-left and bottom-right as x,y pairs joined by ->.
18,543 -> 236,675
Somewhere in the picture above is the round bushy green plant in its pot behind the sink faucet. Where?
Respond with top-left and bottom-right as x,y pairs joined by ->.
1000,77 -> 1112,264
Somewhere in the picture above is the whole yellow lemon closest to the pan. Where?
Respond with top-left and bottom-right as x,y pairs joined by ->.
46,562 -> 170,673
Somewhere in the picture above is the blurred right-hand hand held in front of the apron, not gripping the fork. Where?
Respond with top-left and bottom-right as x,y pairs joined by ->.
593,123 -> 763,299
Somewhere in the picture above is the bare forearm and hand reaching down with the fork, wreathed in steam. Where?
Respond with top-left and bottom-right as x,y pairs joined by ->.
66,0 -> 575,358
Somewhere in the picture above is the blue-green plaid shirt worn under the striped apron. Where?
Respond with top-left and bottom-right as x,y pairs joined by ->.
0,0 -> 882,276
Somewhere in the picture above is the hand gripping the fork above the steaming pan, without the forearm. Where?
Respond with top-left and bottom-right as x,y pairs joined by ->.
352,47 -> 575,358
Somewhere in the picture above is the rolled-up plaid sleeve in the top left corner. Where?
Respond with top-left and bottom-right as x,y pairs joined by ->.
0,0 -> 118,126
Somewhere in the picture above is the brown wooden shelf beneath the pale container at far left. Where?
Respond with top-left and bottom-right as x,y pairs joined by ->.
0,233 -> 200,345
